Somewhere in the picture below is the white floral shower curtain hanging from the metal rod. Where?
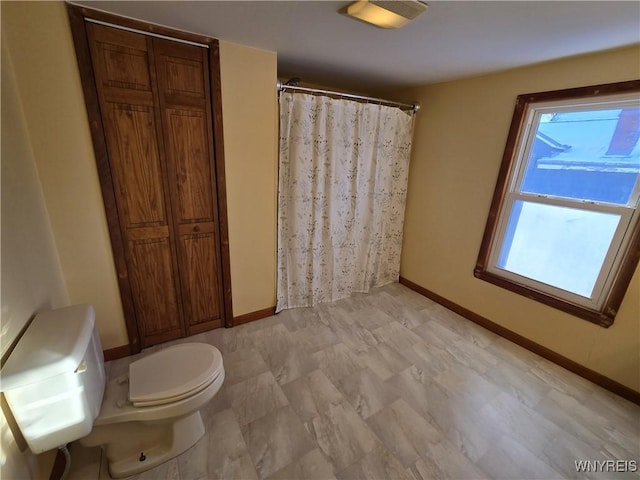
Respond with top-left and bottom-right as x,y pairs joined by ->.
276,92 -> 413,311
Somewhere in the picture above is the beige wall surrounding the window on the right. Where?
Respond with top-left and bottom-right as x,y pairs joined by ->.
396,46 -> 640,391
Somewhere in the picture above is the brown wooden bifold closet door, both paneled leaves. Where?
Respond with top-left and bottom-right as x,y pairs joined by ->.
86,23 -> 223,347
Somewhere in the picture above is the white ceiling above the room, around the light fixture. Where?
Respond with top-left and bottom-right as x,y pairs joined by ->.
74,0 -> 640,90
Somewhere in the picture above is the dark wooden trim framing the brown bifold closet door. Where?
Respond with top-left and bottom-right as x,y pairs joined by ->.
66,3 -> 233,354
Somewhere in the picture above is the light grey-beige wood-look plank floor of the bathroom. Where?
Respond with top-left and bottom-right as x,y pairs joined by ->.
69,284 -> 640,480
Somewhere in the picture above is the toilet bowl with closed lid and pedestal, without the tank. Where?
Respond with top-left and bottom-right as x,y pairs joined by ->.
80,343 -> 224,478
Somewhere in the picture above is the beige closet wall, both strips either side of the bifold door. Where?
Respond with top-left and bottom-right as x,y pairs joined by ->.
2,2 -> 277,349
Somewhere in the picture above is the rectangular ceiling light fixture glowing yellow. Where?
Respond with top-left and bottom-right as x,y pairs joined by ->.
340,0 -> 428,28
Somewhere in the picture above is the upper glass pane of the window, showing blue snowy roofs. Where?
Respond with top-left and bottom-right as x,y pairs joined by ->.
520,107 -> 640,205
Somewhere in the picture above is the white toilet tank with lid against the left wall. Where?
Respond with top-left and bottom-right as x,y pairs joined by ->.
0,305 -> 105,453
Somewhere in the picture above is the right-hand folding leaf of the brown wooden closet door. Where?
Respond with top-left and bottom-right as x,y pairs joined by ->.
153,38 -> 222,333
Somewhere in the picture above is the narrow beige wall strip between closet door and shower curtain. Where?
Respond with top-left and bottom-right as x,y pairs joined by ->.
220,42 -> 278,316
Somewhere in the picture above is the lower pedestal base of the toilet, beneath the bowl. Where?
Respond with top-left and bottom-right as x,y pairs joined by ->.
87,411 -> 204,478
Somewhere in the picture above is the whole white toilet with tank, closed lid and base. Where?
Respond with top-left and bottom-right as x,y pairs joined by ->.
2,305 -> 225,478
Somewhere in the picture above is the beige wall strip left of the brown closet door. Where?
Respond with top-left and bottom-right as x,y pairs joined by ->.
2,2 -> 127,348
